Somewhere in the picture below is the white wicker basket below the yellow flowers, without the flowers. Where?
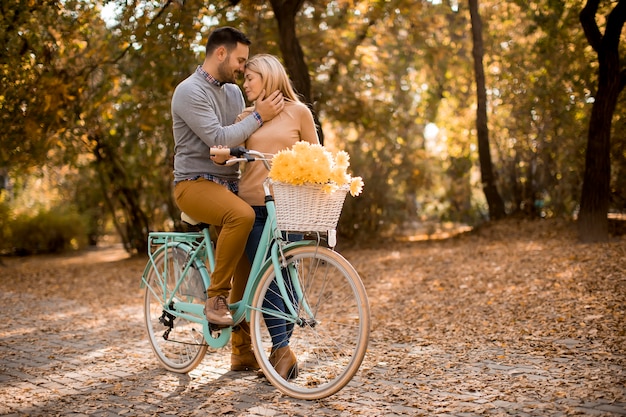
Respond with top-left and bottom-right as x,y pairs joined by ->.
271,182 -> 349,232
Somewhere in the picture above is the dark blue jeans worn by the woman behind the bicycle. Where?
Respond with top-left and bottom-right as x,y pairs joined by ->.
246,206 -> 302,351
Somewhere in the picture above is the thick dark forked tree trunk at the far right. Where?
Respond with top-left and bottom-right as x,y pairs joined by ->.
578,0 -> 626,242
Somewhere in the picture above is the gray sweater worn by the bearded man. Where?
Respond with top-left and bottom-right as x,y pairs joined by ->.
172,72 -> 259,181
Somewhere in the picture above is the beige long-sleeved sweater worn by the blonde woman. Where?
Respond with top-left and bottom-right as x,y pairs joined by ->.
238,101 -> 319,206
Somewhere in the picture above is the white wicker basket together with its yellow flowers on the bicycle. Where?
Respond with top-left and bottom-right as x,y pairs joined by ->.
268,142 -> 363,234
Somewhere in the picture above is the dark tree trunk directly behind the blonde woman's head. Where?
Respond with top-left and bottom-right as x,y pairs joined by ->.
270,0 -> 324,143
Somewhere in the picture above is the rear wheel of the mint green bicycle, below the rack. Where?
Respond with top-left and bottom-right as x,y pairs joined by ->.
144,246 -> 207,373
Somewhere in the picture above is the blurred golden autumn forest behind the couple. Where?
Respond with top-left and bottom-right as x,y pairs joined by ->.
0,0 -> 626,253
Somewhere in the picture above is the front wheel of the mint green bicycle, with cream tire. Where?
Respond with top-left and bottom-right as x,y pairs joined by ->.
250,246 -> 370,400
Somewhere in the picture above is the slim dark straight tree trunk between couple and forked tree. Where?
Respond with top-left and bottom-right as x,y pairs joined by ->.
469,0 -> 506,220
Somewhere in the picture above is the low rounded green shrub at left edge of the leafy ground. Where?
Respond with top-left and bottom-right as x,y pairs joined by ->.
9,207 -> 87,255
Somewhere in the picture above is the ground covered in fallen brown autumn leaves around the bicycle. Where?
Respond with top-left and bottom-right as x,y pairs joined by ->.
0,216 -> 626,416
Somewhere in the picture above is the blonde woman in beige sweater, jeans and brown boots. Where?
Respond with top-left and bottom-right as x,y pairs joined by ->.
231,54 -> 319,379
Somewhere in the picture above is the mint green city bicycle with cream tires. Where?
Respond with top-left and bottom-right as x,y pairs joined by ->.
142,147 -> 370,400
